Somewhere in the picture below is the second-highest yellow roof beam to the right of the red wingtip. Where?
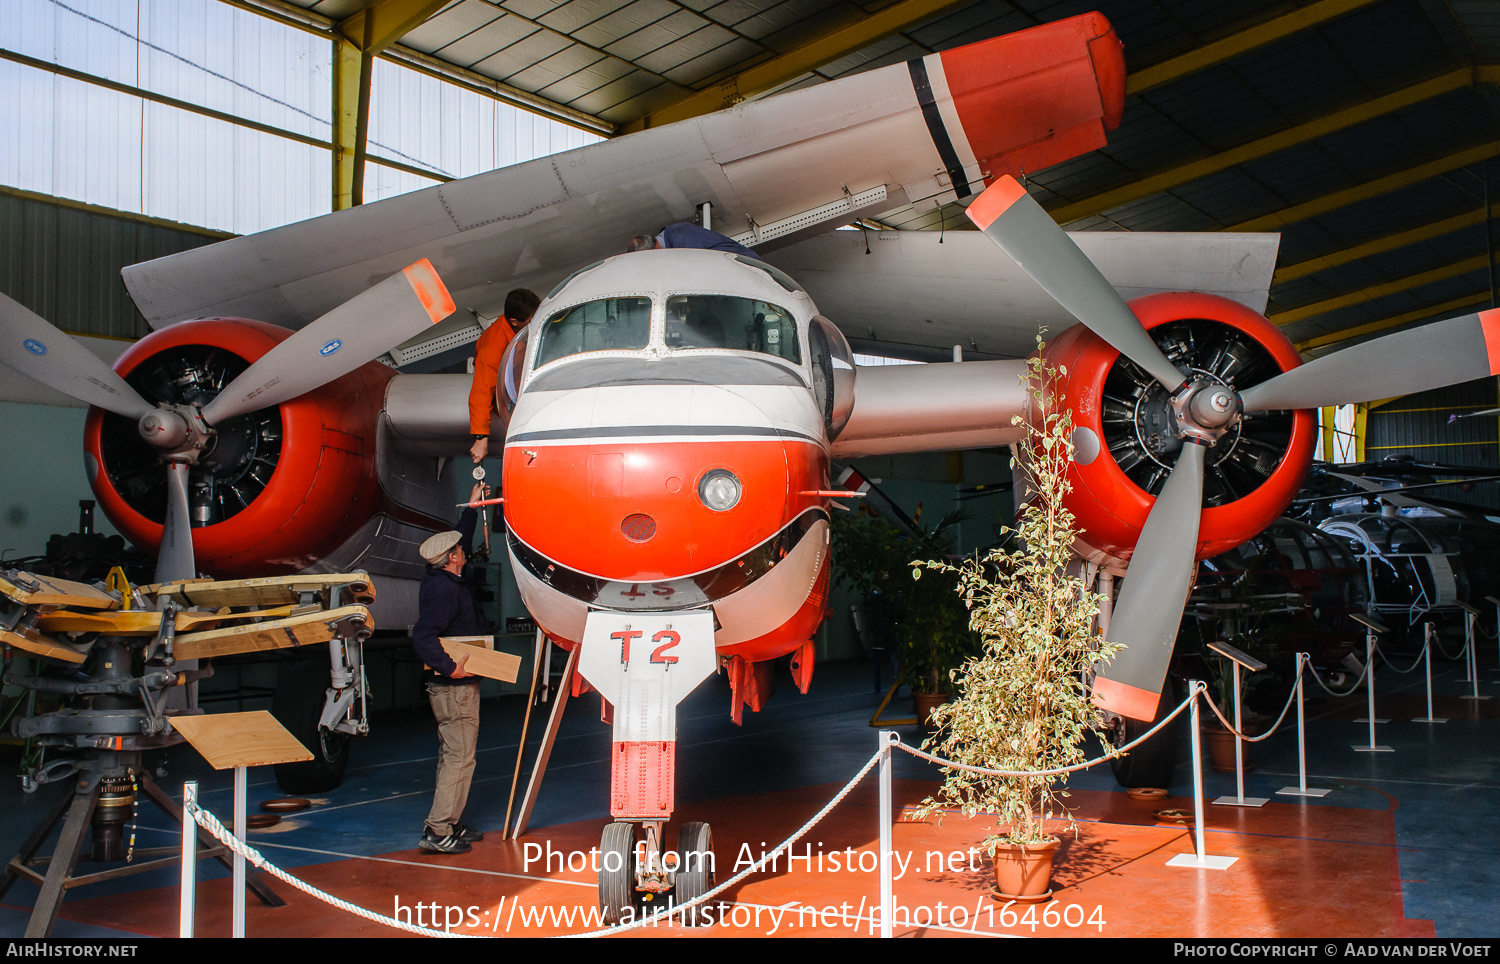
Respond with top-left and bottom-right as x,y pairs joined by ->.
1049,66 -> 1500,225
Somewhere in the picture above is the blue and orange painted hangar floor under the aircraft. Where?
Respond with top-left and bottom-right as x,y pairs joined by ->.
0,660 -> 1500,937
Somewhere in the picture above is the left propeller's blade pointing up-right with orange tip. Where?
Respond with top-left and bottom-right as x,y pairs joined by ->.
203,258 -> 453,426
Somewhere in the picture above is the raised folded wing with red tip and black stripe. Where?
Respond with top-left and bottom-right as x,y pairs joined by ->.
125,13 -> 1124,328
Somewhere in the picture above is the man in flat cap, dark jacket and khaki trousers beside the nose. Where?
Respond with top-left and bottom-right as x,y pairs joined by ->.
411,483 -> 489,853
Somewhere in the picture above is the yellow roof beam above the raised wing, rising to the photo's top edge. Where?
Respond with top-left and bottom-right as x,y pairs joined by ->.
623,0 -> 969,133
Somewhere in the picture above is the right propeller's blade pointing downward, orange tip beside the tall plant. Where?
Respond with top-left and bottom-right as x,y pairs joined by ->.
1094,442 -> 1206,720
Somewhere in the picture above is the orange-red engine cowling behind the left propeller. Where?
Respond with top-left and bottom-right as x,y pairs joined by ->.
84,318 -> 393,577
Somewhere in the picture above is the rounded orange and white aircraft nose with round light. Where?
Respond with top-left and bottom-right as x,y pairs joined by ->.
504,387 -> 822,582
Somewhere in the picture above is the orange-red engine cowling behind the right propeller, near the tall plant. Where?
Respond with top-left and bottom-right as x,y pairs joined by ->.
1044,294 -> 1317,561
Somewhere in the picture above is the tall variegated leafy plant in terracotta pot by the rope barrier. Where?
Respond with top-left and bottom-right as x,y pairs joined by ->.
912,358 -> 1119,900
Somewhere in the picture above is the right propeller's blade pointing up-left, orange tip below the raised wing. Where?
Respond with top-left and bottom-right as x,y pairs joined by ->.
966,174 -> 1185,391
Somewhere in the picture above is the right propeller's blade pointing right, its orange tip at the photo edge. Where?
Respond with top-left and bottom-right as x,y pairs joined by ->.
1241,309 -> 1500,412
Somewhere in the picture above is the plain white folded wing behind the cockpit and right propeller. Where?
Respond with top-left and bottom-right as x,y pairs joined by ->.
767,231 -> 1281,358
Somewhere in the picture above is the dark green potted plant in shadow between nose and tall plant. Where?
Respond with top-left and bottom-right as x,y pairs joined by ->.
833,510 -> 978,723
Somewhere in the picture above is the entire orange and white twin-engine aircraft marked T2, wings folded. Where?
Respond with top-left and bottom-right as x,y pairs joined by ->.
0,15 -> 1500,915
